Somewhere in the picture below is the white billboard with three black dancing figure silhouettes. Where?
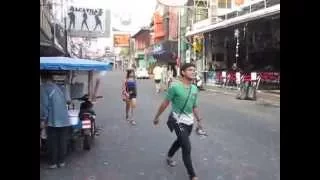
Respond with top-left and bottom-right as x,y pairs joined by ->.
67,5 -> 111,38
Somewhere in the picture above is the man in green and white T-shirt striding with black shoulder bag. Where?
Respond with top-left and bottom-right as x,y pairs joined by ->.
153,63 -> 202,180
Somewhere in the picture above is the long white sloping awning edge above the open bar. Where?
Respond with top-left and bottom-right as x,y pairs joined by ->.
186,4 -> 280,36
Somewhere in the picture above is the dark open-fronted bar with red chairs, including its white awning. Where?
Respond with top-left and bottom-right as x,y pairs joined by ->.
187,2 -> 280,89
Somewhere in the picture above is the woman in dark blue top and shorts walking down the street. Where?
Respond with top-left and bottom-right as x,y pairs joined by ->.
122,69 -> 137,125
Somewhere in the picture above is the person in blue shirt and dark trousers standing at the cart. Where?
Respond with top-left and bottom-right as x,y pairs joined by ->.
40,72 -> 71,169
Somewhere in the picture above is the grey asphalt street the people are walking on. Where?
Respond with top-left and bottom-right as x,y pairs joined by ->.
40,72 -> 280,180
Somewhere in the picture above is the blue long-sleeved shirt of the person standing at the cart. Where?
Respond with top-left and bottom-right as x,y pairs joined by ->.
40,83 -> 71,127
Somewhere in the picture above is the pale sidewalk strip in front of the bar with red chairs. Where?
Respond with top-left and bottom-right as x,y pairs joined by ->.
204,85 -> 280,107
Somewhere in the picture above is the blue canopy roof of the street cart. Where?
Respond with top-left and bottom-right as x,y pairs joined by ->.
40,57 -> 112,71
